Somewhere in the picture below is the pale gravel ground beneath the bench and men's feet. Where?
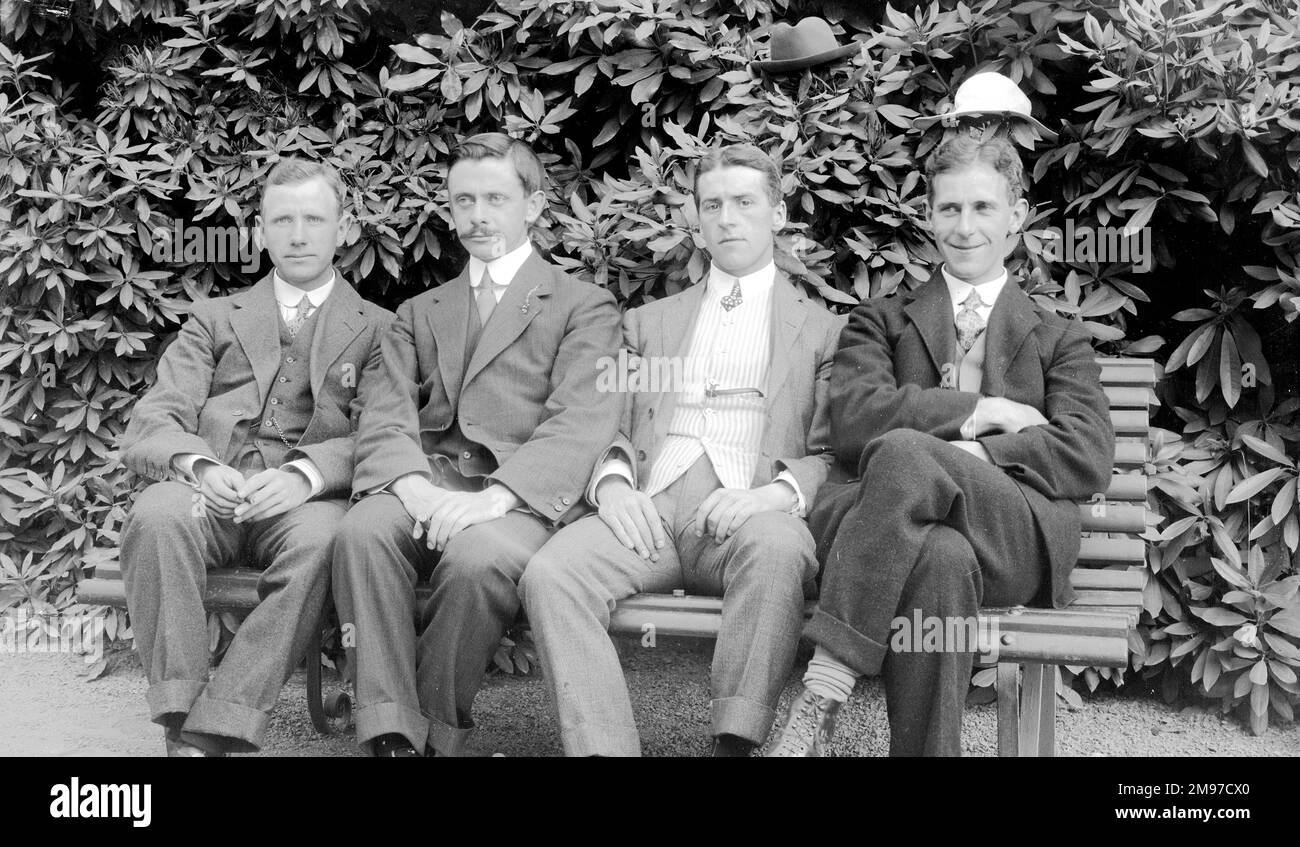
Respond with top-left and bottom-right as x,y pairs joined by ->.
0,640 -> 1300,756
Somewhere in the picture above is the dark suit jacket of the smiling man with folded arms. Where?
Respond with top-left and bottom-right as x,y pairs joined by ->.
831,270 -> 1114,605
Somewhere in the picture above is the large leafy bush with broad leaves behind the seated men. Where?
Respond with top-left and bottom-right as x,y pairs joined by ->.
0,0 -> 1300,730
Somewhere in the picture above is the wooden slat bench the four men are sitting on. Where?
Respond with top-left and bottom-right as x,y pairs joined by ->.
77,359 -> 1156,756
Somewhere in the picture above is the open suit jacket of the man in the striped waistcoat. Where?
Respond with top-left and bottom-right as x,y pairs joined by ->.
597,272 -> 844,508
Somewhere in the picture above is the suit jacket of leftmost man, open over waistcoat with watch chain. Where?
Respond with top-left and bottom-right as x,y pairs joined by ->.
120,269 -> 393,496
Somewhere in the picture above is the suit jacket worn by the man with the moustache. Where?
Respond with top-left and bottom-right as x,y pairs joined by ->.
352,252 -> 619,524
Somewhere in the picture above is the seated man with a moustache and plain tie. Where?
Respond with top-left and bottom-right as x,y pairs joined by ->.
334,134 -> 619,756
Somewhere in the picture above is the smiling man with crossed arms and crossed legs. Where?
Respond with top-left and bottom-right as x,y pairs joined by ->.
768,135 -> 1113,756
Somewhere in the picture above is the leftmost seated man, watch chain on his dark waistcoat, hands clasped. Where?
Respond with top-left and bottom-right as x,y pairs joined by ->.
121,158 -> 393,756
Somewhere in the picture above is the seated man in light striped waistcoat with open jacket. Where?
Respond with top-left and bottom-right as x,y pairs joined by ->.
520,144 -> 842,756
